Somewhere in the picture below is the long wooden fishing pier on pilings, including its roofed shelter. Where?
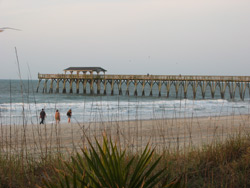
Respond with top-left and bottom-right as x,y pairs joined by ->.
37,67 -> 250,100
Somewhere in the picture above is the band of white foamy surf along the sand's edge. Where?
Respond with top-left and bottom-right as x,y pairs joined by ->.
0,99 -> 249,125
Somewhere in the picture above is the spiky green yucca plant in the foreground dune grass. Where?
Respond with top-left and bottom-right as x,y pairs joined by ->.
44,137 -> 180,188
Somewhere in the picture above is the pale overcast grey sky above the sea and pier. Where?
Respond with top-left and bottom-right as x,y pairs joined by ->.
0,0 -> 250,79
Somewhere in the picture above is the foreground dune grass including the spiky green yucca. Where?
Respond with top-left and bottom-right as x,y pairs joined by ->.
0,131 -> 250,188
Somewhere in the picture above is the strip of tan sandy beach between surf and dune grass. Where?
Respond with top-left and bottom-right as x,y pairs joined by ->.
0,115 -> 250,155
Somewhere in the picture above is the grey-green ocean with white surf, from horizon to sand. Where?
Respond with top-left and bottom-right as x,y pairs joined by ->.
0,80 -> 250,125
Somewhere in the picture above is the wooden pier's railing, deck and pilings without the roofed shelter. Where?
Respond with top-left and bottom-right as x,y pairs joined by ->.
37,74 -> 250,100
